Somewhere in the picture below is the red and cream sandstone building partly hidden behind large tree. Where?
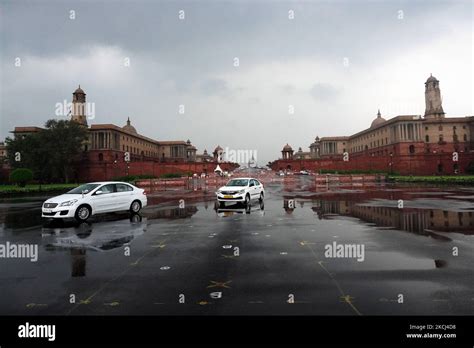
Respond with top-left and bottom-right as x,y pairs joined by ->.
6,86 -> 236,181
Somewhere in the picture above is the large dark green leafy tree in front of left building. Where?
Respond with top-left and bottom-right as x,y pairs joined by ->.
6,120 -> 87,182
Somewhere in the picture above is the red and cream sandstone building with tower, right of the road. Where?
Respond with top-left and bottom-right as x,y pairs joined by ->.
272,76 -> 474,175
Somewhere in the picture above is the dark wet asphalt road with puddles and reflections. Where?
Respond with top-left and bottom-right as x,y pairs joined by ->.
0,178 -> 474,315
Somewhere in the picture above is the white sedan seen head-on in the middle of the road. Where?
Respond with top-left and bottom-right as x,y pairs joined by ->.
216,178 -> 265,207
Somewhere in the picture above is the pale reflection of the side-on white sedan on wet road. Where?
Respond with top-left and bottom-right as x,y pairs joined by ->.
48,214 -> 146,251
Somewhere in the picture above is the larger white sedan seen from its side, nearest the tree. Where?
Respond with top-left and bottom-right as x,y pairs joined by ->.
41,182 -> 147,221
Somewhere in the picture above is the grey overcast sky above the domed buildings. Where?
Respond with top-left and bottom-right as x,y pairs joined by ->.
0,0 -> 474,164
